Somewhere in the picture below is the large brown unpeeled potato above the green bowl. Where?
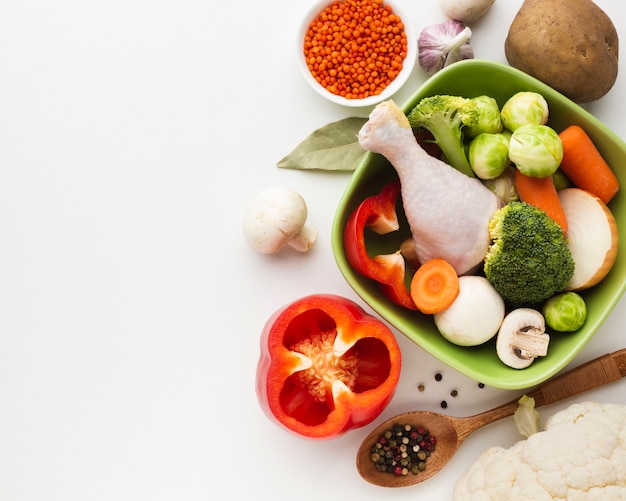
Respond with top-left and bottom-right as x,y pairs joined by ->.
504,0 -> 619,103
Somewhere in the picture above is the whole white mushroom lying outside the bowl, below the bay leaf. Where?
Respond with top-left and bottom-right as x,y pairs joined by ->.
242,187 -> 317,254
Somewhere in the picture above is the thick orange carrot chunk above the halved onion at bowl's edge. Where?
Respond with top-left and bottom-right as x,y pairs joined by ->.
559,125 -> 619,204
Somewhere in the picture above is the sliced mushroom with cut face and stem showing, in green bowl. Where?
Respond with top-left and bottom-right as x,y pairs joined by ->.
496,308 -> 550,369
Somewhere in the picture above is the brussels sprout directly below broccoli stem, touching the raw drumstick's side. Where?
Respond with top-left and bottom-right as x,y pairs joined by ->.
468,133 -> 510,179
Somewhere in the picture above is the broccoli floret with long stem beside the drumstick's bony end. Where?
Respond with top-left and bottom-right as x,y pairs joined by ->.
407,94 -> 480,177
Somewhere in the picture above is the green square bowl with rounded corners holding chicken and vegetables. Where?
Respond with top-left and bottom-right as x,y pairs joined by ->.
332,60 -> 626,389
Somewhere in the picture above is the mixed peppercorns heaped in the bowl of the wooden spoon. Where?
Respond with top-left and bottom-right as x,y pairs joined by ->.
370,424 -> 437,475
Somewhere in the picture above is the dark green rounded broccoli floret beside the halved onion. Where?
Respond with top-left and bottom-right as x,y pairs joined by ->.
484,201 -> 574,307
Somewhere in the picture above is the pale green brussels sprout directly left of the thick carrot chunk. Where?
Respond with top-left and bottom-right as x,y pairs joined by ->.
509,125 -> 563,177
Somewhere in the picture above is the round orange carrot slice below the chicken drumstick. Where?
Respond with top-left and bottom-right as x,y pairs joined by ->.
410,258 -> 459,314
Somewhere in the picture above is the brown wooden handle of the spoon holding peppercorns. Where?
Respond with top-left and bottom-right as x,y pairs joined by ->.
457,348 -> 626,441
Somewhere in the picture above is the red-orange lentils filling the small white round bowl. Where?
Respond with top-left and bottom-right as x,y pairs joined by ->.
304,0 -> 408,99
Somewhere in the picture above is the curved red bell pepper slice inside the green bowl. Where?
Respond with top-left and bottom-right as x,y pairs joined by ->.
343,181 -> 417,310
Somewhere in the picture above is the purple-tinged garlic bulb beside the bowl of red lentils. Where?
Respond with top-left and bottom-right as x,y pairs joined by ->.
417,20 -> 474,75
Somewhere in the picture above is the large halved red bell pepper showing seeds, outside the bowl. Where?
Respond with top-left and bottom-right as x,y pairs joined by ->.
256,294 -> 402,440
